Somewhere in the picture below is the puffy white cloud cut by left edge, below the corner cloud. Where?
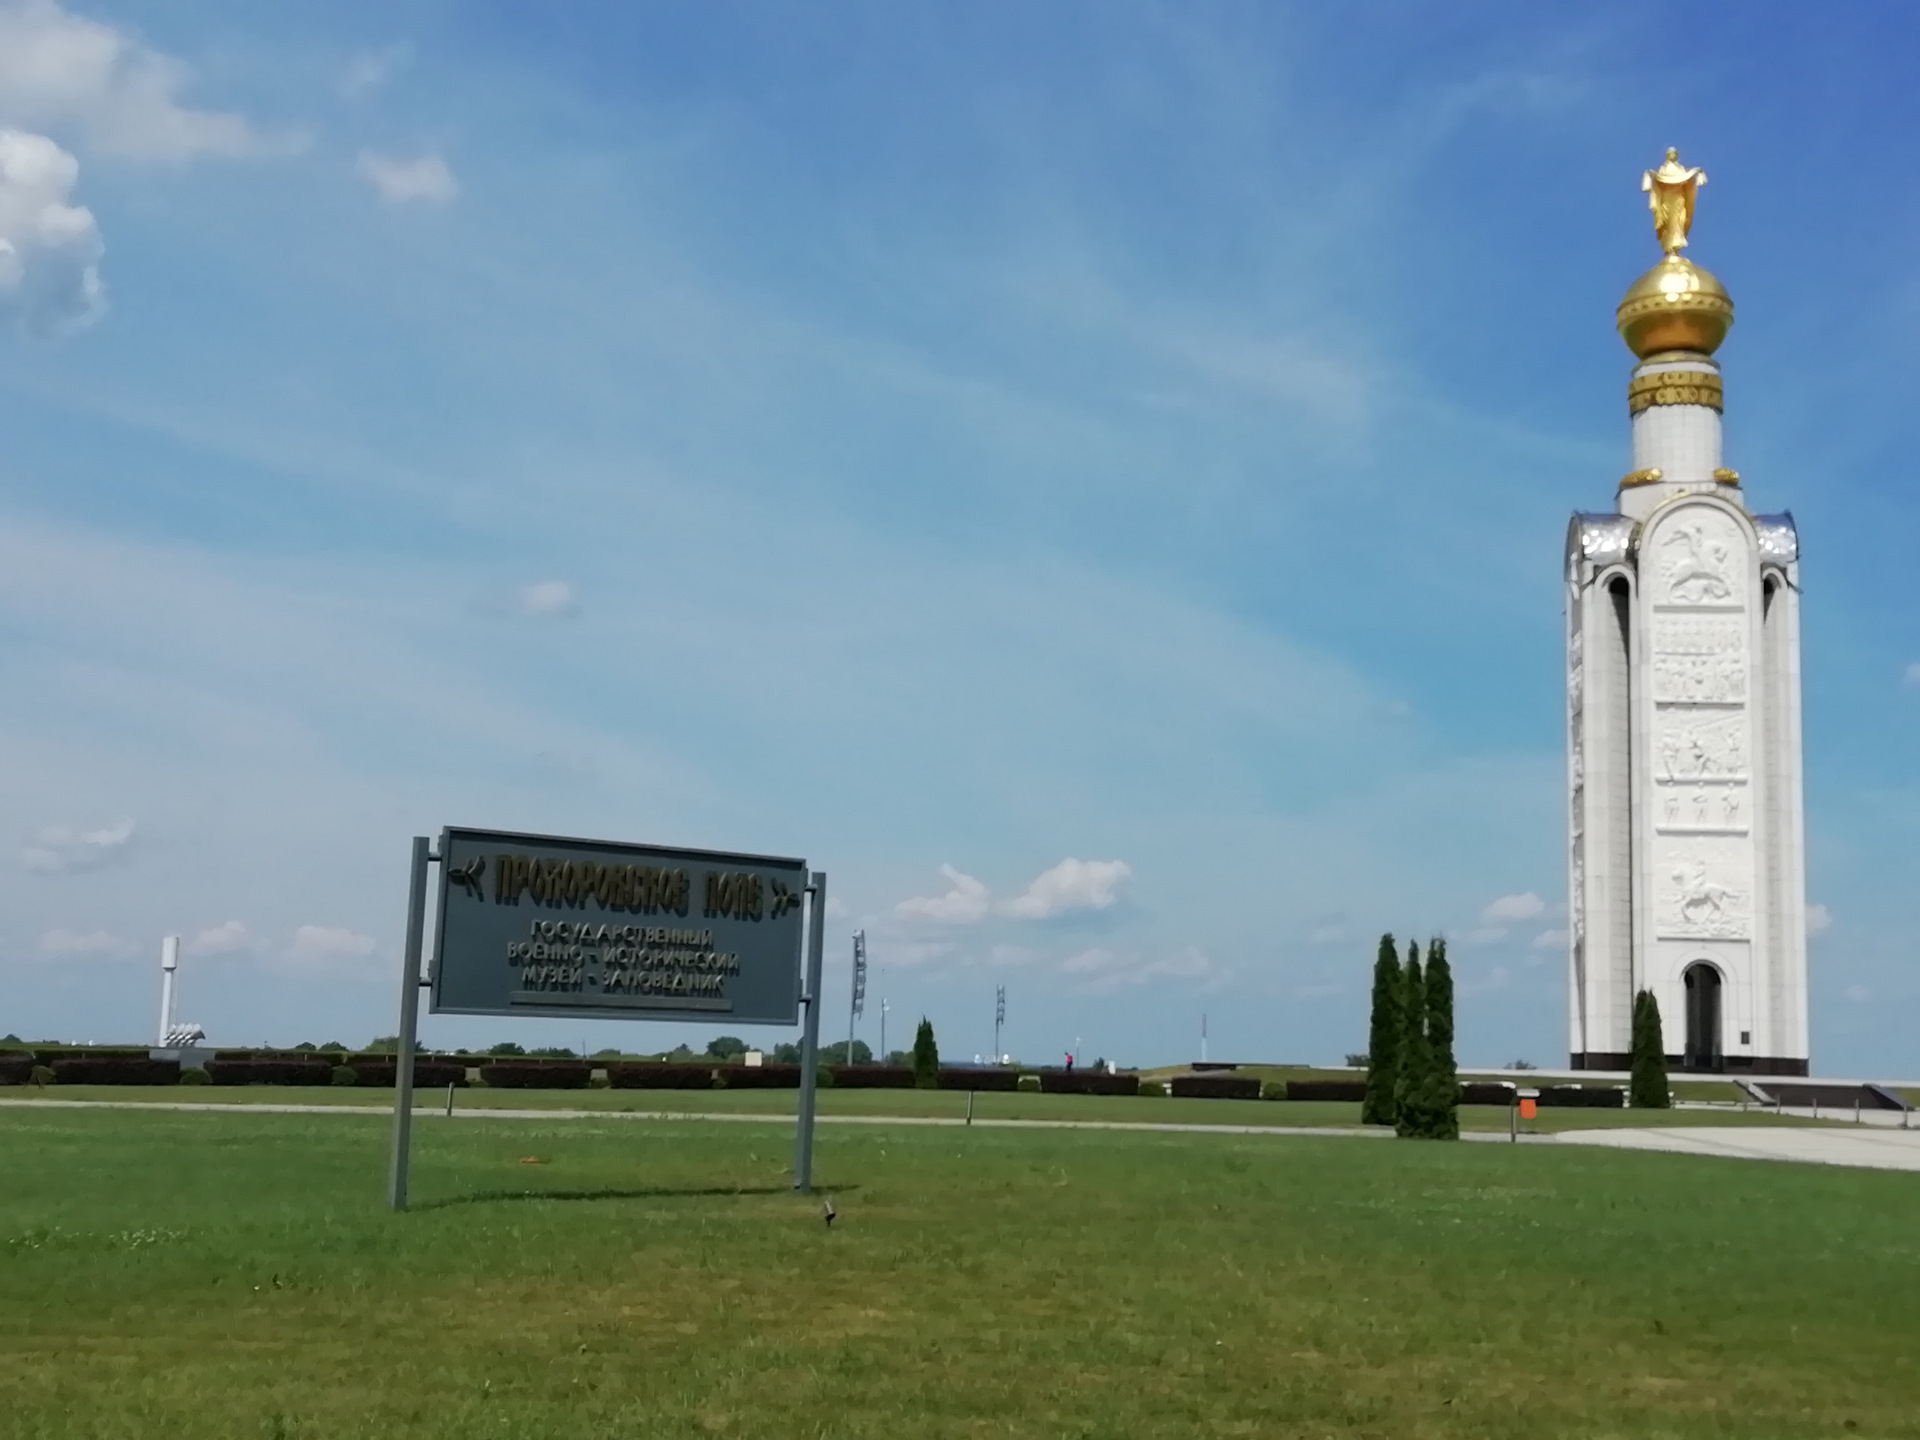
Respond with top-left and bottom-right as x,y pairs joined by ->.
0,131 -> 106,334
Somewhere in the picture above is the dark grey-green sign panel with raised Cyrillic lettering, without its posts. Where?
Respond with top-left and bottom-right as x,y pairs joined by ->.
430,829 -> 806,1025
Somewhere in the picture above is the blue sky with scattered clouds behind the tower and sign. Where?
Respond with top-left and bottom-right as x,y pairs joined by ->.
0,0 -> 1920,1075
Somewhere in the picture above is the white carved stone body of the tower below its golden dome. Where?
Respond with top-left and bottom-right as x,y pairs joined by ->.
1567,353 -> 1809,1073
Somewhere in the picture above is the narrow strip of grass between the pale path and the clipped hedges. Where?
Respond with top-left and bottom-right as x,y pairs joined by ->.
0,1085 -> 1837,1133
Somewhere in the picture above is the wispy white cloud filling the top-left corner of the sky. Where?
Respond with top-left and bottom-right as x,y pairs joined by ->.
0,0 -> 280,161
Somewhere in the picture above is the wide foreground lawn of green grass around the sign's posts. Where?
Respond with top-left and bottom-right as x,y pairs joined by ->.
0,1108 -> 1920,1440
